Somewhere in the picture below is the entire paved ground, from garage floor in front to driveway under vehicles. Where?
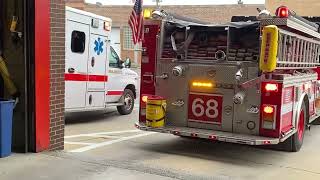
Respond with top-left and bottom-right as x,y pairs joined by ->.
0,67 -> 320,180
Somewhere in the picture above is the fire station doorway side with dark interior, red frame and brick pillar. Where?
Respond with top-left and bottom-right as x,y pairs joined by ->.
0,0 -> 65,152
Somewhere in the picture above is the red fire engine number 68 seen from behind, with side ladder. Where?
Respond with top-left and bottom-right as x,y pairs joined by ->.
136,7 -> 320,151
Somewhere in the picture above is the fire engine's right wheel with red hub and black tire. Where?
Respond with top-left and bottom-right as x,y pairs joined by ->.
284,103 -> 308,152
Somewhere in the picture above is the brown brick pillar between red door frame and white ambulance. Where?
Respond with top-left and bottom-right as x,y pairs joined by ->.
50,0 -> 65,150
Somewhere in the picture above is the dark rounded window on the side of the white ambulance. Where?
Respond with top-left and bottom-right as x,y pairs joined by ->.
71,31 -> 86,53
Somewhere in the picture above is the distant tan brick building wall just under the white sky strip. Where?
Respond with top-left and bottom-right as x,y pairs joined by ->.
83,4 -> 264,27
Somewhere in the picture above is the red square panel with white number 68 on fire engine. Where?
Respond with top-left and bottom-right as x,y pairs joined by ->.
188,93 -> 223,123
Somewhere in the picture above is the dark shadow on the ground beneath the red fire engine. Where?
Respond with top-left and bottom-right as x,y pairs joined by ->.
140,137 -> 294,166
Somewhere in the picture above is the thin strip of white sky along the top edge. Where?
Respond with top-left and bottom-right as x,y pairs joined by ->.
86,0 -> 265,5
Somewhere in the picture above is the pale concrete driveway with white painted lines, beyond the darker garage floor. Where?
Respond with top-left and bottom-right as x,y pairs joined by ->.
60,105 -> 320,180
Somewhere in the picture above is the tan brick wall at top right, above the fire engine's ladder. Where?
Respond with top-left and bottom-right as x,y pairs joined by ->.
266,0 -> 320,16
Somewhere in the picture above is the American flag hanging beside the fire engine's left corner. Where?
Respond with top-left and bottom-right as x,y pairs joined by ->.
129,0 -> 143,44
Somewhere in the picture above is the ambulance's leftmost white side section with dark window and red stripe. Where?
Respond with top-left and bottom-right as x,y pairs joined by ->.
65,20 -> 90,110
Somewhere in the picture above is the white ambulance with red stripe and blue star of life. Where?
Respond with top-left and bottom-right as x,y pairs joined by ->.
65,7 -> 138,115
